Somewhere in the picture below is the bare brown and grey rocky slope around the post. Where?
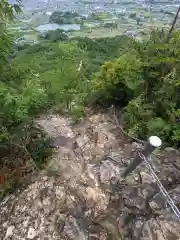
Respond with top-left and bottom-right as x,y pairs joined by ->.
0,111 -> 180,240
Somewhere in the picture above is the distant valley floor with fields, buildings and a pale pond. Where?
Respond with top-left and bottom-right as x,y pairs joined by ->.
9,0 -> 178,42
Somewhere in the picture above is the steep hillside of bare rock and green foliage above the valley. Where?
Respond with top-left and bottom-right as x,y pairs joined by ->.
0,1 -> 180,240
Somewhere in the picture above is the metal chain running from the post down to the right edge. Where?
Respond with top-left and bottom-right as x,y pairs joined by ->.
137,151 -> 180,221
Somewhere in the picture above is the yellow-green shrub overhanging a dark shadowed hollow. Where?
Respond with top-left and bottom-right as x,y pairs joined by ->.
92,54 -> 143,106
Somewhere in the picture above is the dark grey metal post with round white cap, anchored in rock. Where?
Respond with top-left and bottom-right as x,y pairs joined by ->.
121,136 -> 162,178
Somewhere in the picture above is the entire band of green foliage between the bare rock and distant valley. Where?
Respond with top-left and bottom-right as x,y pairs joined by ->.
0,1 -> 180,199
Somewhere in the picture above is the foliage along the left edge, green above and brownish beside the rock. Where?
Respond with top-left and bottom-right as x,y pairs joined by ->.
0,0 -> 50,195
